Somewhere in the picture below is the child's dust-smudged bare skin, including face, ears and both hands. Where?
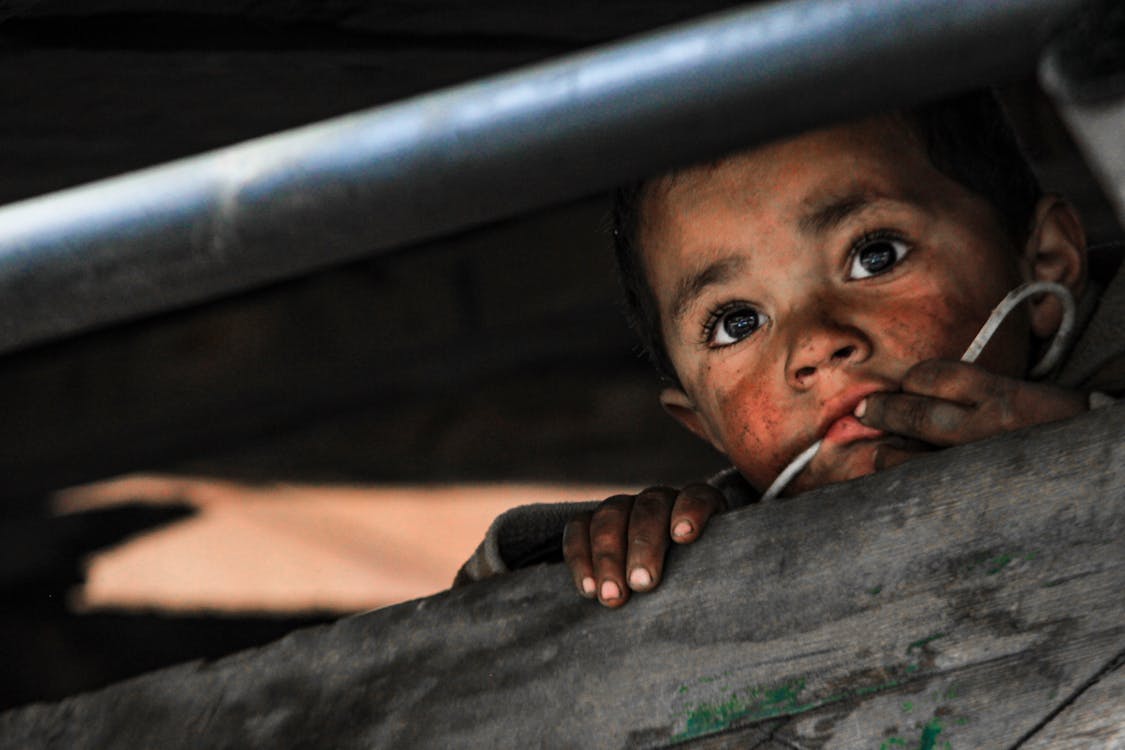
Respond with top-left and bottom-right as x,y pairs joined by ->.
564,117 -> 1088,607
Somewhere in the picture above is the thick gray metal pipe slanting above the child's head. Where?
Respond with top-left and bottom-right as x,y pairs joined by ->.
0,0 -> 1078,352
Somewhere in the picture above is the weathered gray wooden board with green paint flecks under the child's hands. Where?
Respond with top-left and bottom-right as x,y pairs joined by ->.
0,406 -> 1125,750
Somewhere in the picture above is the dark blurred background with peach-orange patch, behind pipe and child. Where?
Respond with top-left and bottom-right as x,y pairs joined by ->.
0,0 -> 1117,707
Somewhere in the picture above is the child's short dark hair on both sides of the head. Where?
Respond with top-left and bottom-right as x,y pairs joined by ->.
611,90 -> 1042,383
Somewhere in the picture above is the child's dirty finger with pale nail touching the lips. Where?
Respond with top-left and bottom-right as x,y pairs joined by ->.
856,394 -> 974,445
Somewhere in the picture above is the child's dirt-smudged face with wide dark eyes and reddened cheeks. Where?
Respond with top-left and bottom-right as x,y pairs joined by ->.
640,119 -> 1031,489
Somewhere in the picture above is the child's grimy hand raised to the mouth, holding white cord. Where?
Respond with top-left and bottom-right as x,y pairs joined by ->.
855,360 -> 1088,469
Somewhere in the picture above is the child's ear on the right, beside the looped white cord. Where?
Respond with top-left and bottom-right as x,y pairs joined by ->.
1023,196 -> 1086,338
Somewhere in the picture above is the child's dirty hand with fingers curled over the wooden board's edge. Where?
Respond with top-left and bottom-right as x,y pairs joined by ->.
563,485 -> 727,607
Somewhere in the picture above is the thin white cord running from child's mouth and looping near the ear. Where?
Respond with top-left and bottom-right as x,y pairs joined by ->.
762,281 -> 1077,500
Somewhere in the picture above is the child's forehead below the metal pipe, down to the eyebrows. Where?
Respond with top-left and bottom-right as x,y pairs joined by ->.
640,117 -> 991,323
